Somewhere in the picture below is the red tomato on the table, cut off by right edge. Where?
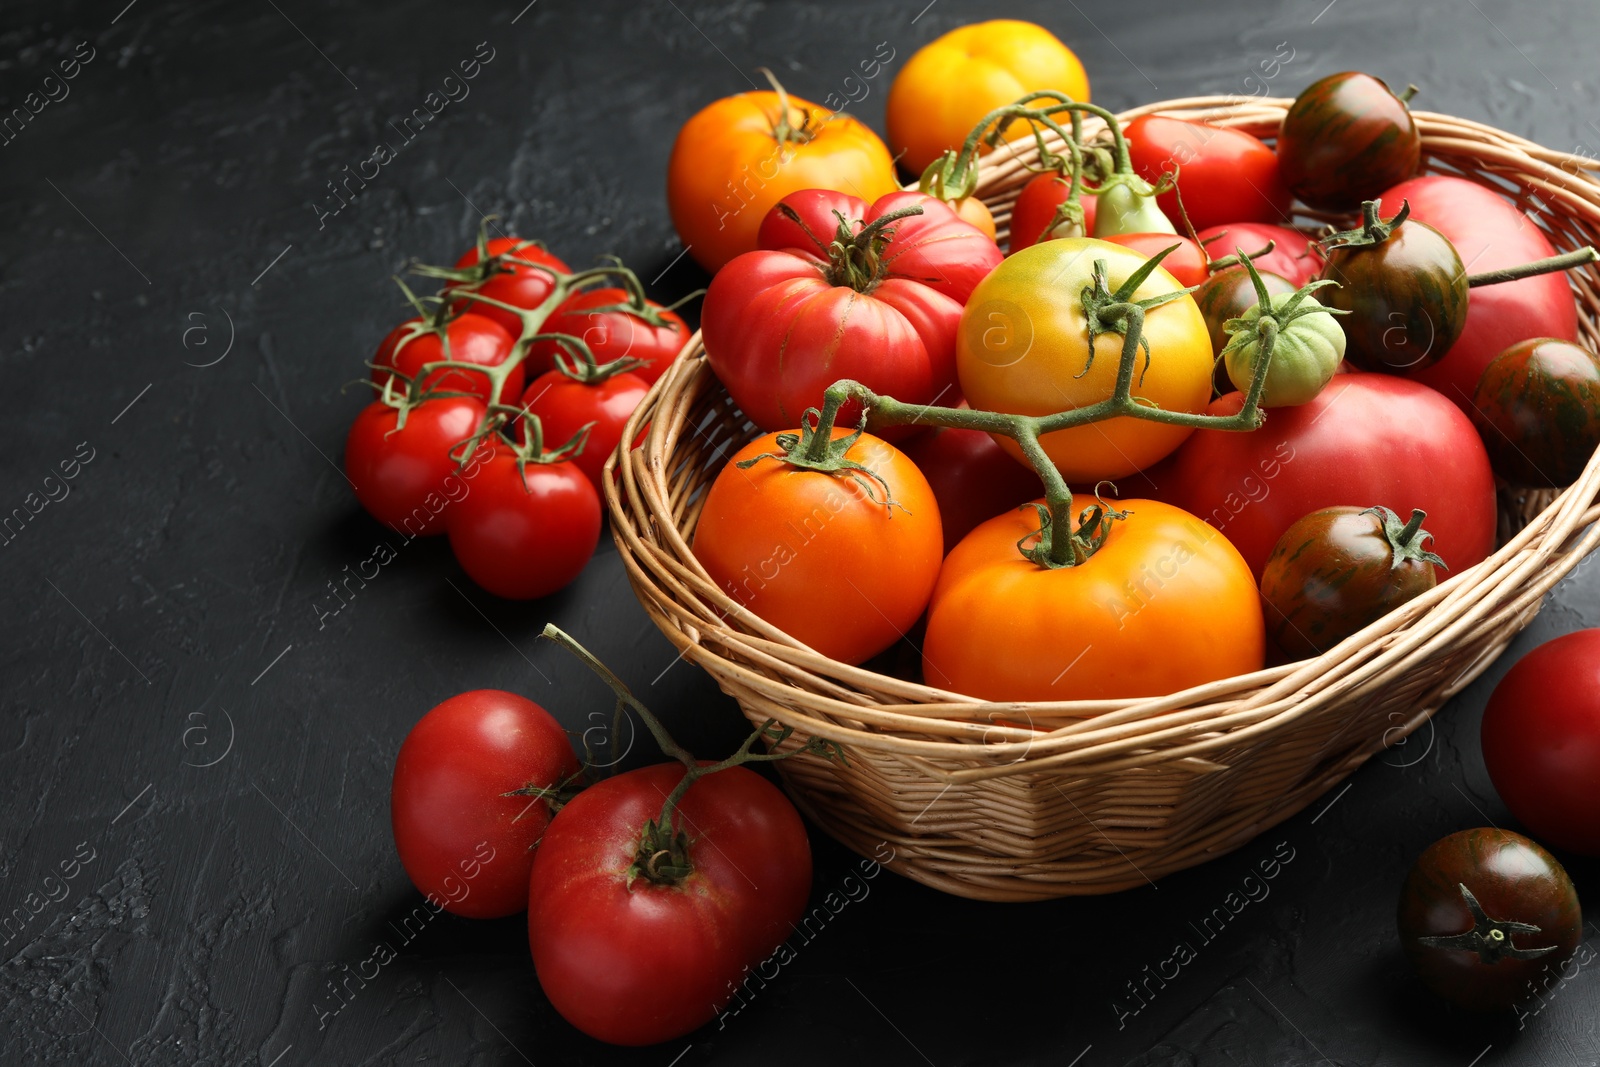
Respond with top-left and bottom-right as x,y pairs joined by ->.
1483,630 -> 1600,856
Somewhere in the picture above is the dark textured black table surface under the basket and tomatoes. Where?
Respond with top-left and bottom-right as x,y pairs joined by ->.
0,0 -> 1600,1067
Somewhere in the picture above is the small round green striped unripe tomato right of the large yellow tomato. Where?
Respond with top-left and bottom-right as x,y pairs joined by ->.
1222,293 -> 1344,408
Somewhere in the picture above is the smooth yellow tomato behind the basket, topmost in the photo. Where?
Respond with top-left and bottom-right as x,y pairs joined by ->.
888,19 -> 1090,174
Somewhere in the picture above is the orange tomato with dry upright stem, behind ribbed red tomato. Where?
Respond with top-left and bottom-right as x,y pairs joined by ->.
667,90 -> 899,270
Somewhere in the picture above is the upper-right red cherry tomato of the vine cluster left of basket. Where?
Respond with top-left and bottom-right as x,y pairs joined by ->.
523,286 -> 690,382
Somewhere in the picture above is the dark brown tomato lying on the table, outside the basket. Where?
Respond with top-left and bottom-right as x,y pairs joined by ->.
1398,827 -> 1582,1011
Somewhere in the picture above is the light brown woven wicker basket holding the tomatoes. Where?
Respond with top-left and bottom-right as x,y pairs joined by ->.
606,98 -> 1600,901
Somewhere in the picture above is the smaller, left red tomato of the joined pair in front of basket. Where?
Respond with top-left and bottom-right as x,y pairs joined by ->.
389,689 -> 579,918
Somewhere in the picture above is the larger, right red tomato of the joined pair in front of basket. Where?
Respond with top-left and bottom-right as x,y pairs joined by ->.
528,763 -> 811,1045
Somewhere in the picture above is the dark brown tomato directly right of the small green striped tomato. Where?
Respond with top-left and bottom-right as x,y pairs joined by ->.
1317,219 -> 1467,373
